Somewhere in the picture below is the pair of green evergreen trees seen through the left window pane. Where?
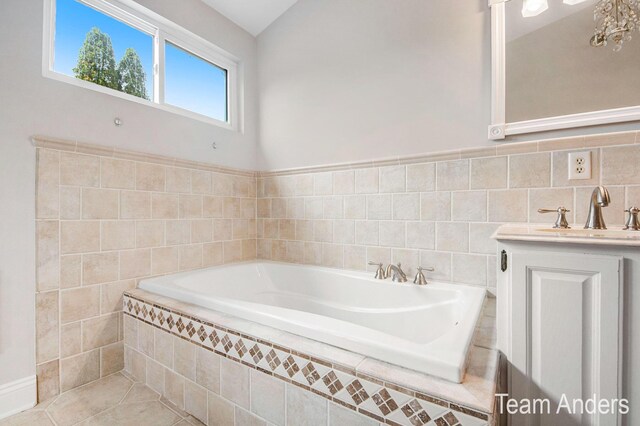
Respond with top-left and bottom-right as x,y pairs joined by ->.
73,27 -> 149,99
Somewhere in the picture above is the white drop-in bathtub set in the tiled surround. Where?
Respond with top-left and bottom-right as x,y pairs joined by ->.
139,262 -> 485,382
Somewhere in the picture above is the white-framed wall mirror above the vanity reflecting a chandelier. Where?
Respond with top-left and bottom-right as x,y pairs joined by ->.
489,0 -> 640,139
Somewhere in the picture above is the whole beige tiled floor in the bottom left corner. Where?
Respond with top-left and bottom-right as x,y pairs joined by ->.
0,373 -> 202,426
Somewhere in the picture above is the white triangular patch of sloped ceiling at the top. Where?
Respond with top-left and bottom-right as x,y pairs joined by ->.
202,0 -> 298,36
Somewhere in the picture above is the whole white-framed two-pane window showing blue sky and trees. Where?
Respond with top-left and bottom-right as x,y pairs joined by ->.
43,0 -> 238,129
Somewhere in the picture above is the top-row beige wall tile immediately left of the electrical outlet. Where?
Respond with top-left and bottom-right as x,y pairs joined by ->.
509,152 -> 551,188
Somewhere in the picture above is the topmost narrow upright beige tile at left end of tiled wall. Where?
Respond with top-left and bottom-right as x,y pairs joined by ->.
36,149 -> 60,219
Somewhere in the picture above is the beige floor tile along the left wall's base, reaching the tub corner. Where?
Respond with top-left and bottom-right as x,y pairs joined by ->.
47,374 -> 133,426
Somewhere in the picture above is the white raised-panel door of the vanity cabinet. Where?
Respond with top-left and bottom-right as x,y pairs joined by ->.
510,253 -> 622,426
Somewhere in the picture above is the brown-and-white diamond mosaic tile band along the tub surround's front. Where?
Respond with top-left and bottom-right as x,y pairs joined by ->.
123,293 -> 490,426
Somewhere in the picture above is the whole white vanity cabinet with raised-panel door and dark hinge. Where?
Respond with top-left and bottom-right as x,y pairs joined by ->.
494,226 -> 640,426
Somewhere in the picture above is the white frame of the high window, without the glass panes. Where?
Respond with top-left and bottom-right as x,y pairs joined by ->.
42,0 -> 241,131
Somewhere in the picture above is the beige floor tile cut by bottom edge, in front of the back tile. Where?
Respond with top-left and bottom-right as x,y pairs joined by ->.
80,401 -> 180,426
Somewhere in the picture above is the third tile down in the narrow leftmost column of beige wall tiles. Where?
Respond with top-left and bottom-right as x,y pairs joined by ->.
36,291 -> 60,364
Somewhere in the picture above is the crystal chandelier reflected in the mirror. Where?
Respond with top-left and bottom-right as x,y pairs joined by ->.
591,0 -> 640,52
